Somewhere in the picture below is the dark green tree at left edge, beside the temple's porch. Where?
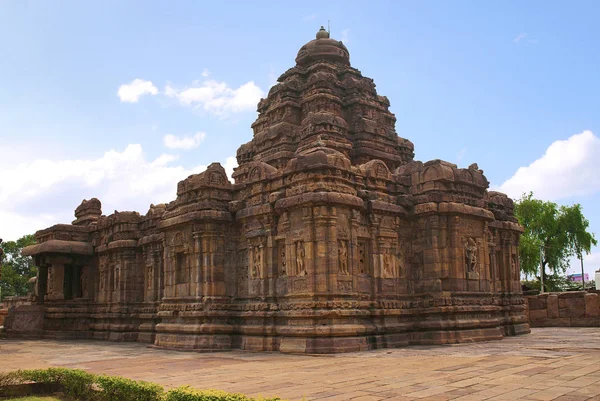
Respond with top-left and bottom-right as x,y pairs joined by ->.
0,235 -> 36,297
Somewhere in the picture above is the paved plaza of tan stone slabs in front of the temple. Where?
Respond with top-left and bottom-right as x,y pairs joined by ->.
0,328 -> 600,401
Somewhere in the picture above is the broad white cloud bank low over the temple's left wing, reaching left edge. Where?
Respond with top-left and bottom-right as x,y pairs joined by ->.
0,144 -> 235,241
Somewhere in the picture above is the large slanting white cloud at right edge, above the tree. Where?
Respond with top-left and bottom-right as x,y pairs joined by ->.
498,131 -> 600,200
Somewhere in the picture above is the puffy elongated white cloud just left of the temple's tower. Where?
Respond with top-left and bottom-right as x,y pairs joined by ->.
165,80 -> 264,116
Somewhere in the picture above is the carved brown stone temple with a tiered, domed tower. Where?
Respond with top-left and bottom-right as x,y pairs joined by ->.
12,29 -> 529,353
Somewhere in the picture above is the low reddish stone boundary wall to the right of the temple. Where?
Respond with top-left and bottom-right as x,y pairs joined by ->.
525,291 -> 600,327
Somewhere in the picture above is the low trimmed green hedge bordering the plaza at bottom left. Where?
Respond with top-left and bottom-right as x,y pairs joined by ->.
0,368 -> 281,401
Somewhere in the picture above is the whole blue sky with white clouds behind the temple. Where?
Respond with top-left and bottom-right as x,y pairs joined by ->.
0,0 -> 600,278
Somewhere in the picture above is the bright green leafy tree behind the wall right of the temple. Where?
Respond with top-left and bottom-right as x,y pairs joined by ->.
515,192 -> 597,290
